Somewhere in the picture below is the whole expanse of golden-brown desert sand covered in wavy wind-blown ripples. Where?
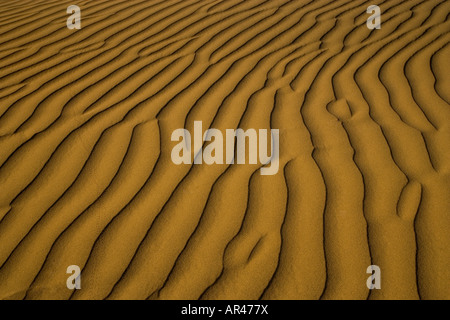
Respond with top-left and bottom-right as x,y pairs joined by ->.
0,0 -> 450,299
